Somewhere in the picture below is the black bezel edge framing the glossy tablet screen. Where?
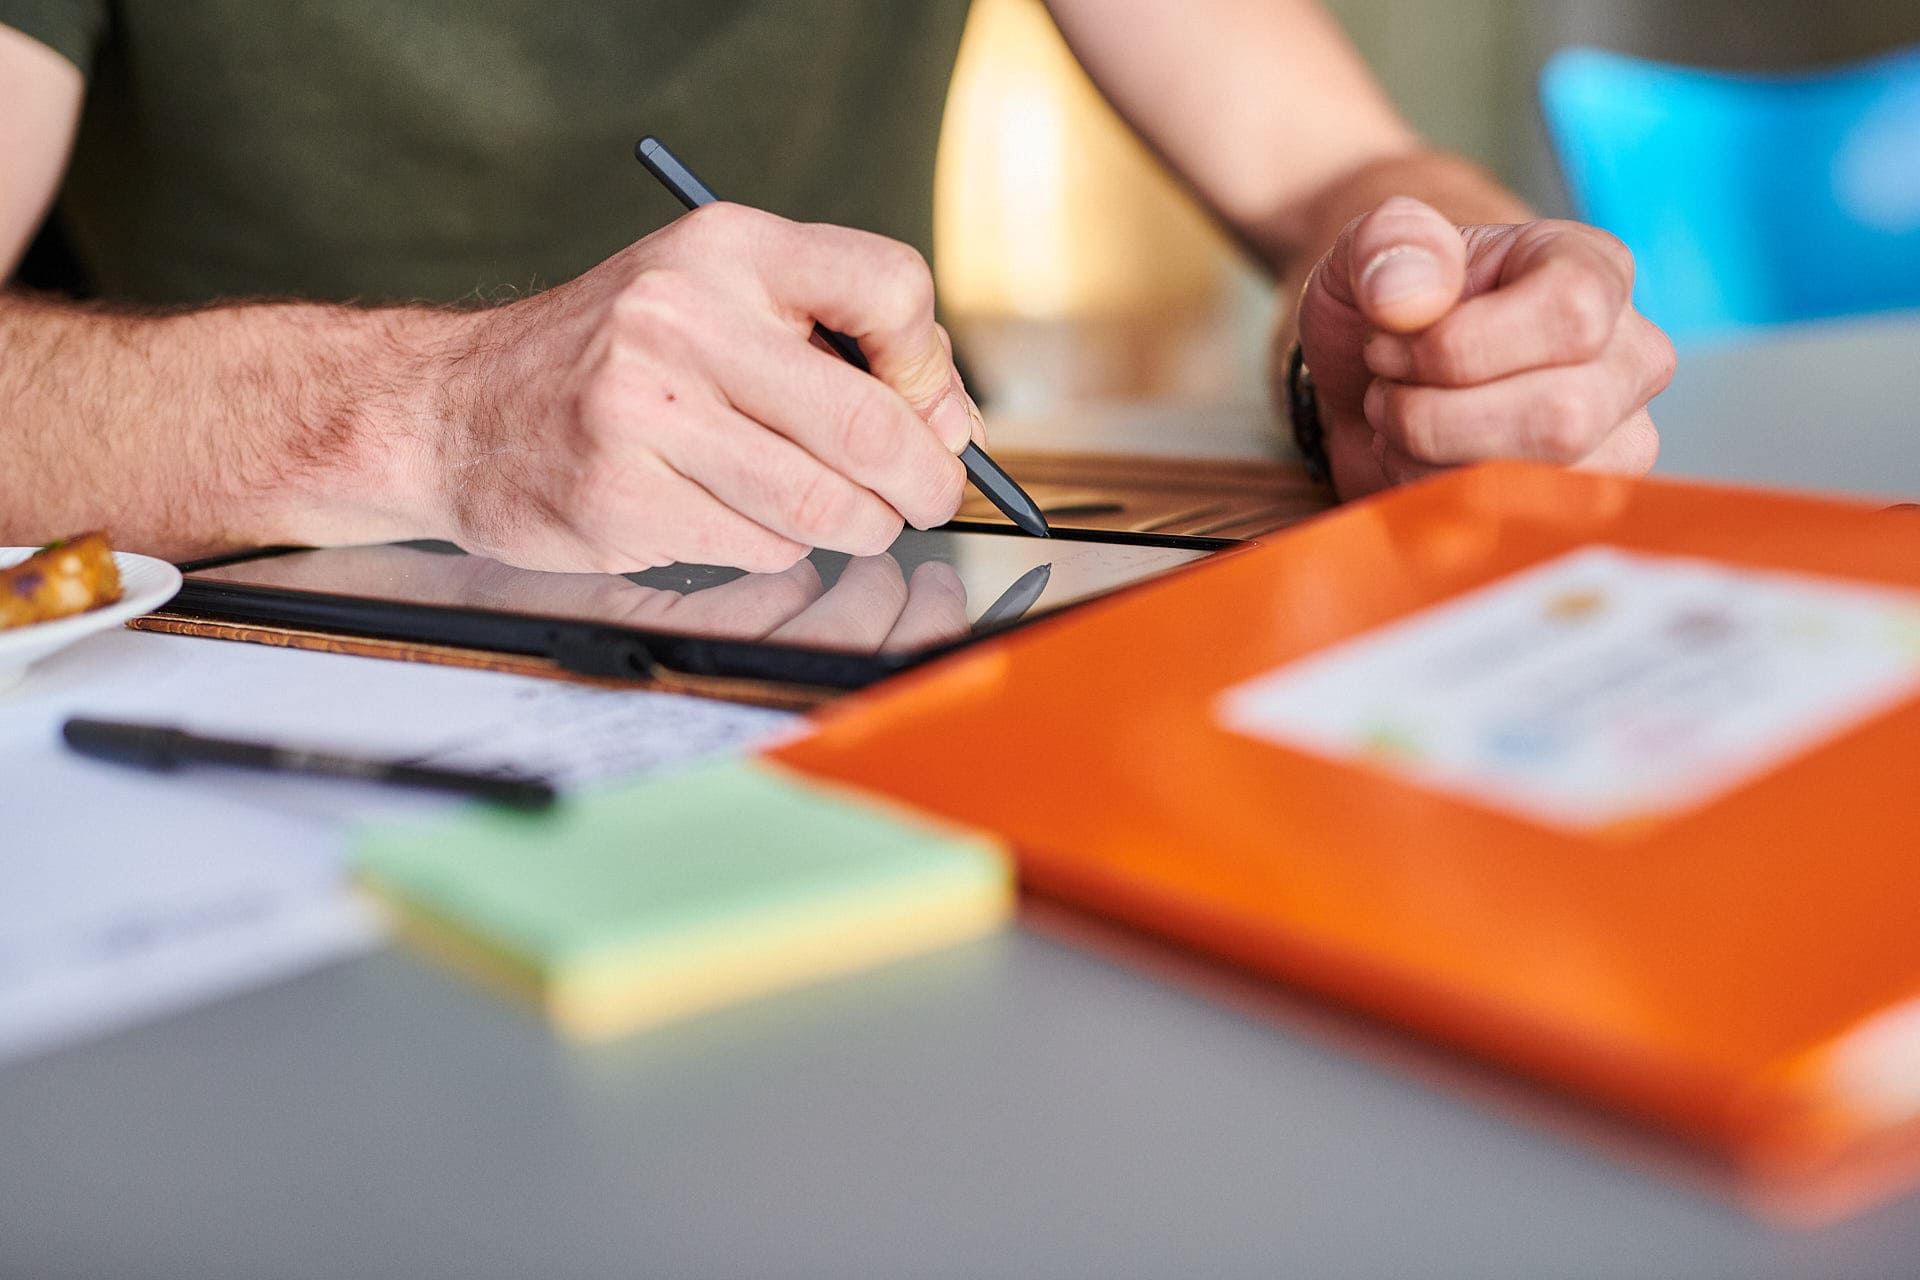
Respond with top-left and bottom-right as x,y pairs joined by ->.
165,520 -> 1242,689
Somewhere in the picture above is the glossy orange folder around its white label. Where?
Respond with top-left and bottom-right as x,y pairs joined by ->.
774,464 -> 1920,1203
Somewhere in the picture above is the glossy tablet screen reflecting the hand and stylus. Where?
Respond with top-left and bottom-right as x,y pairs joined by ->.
188,528 -> 1213,654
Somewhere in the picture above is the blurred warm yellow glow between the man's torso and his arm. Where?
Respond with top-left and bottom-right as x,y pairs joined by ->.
933,0 -> 1259,404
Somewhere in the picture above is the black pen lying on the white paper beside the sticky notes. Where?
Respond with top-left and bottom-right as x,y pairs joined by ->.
61,720 -> 555,810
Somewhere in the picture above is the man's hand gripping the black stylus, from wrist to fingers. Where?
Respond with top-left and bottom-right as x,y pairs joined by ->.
430,203 -> 979,572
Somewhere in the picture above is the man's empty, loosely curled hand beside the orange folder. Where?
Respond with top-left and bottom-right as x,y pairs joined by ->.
1300,198 -> 1674,497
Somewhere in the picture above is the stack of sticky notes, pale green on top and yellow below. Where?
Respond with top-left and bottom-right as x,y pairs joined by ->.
357,760 -> 1012,1038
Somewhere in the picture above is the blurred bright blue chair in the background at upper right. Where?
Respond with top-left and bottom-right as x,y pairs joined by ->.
1540,46 -> 1920,342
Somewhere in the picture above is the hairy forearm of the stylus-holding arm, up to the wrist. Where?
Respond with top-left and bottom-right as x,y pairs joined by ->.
0,292 -> 455,558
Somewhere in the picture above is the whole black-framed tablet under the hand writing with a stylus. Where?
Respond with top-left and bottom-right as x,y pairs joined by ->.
169,522 -> 1238,689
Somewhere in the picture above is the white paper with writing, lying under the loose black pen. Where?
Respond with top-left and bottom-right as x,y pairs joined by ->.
0,631 -> 801,1061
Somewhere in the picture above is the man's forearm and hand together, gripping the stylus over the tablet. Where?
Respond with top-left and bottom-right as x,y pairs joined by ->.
0,203 -> 979,574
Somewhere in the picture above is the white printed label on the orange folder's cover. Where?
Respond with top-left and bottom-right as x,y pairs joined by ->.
1219,547 -> 1920,829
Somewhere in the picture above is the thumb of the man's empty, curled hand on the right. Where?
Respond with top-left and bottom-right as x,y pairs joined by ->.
1323,196 -> 1467,334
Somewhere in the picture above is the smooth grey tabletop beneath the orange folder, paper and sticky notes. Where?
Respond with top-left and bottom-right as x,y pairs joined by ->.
0,322 -> 1920,1280
